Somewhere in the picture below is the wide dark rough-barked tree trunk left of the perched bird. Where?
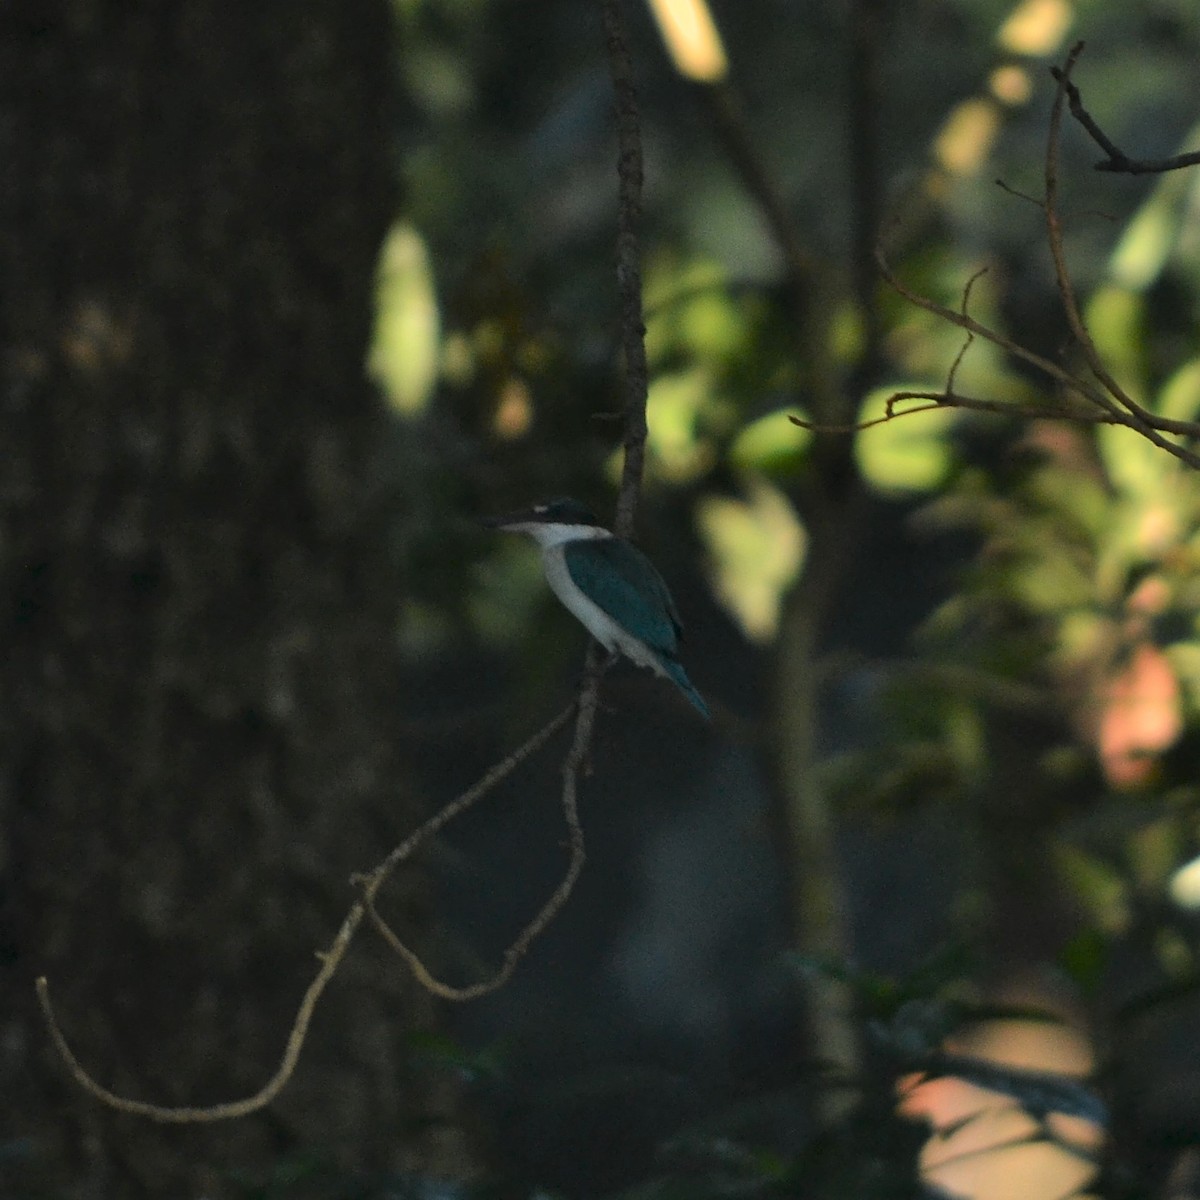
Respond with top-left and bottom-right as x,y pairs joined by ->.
0,0 -> 463,1198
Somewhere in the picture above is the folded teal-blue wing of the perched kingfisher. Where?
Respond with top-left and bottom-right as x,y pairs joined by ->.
563,538 -> 682,655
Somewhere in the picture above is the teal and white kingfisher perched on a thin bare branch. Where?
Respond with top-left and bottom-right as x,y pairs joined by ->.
484,497 -> 710,720
